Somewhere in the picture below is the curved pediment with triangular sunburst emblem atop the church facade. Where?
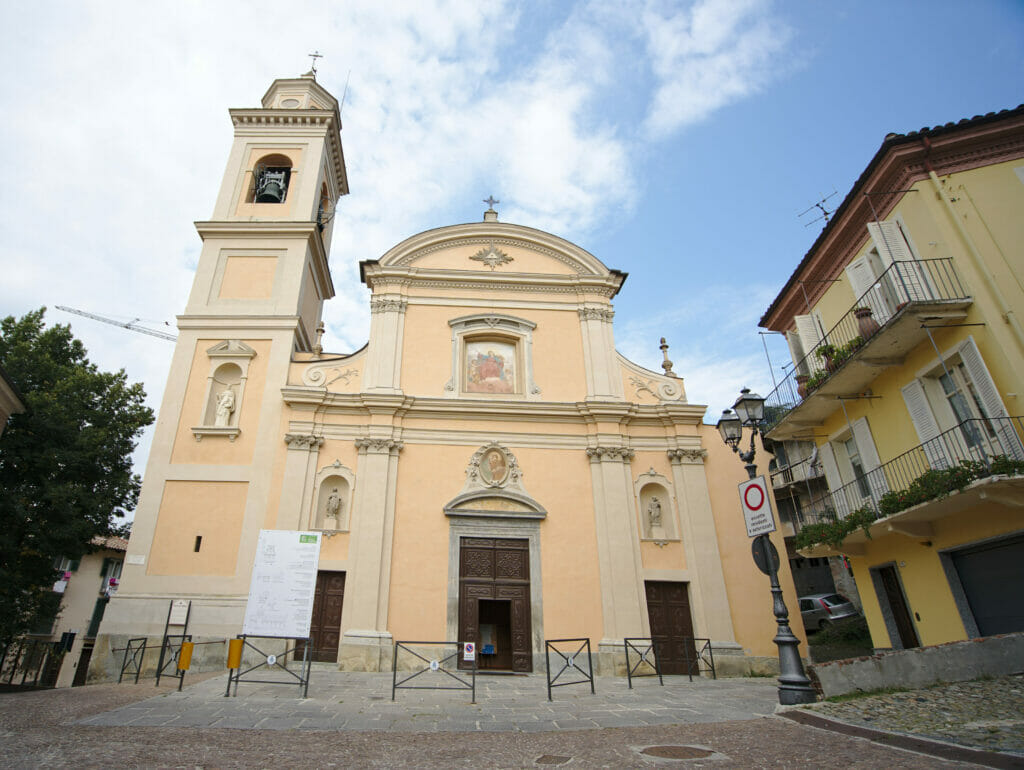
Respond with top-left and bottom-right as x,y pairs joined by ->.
376,221 -> 618,276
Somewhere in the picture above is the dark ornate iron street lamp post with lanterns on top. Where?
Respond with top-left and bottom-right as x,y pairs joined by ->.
718,388 -> 817,705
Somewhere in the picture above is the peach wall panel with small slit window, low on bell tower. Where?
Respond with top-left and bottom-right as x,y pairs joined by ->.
145,481 -> 249,575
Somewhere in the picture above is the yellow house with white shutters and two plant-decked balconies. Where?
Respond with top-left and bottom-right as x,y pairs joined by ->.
761,106 -> 1024,649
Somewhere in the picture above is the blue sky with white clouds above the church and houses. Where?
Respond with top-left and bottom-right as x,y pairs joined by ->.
0,0 -> 1024,483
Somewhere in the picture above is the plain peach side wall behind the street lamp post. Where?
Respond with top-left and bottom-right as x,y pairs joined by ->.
701,425 -> 807,657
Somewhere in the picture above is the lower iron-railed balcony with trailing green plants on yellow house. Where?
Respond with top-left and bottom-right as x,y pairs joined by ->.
798,417 -> 1024,556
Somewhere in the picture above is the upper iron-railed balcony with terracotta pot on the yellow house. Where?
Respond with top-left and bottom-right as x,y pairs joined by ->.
765,258 -> 972,440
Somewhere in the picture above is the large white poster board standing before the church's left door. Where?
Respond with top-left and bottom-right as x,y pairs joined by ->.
242,529 -> 321,639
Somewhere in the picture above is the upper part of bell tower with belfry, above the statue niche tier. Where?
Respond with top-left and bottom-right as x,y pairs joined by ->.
181,73 -> 348,350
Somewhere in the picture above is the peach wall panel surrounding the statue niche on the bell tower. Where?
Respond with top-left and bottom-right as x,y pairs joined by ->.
171,339 -> 270,465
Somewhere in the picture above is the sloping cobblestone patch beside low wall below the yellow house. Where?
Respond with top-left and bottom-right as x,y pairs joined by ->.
807,675 -> 1024,764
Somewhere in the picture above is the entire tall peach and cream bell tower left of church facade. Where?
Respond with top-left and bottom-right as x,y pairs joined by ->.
94,73 -> 348,671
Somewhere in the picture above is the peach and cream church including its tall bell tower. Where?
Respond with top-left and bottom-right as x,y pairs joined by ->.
94,75 -> 794,677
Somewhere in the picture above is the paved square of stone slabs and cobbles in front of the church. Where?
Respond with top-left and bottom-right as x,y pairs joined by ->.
0,672 -> 1020,768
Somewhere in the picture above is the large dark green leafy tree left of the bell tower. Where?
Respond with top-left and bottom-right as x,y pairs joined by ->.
0,308 -> 153,644
